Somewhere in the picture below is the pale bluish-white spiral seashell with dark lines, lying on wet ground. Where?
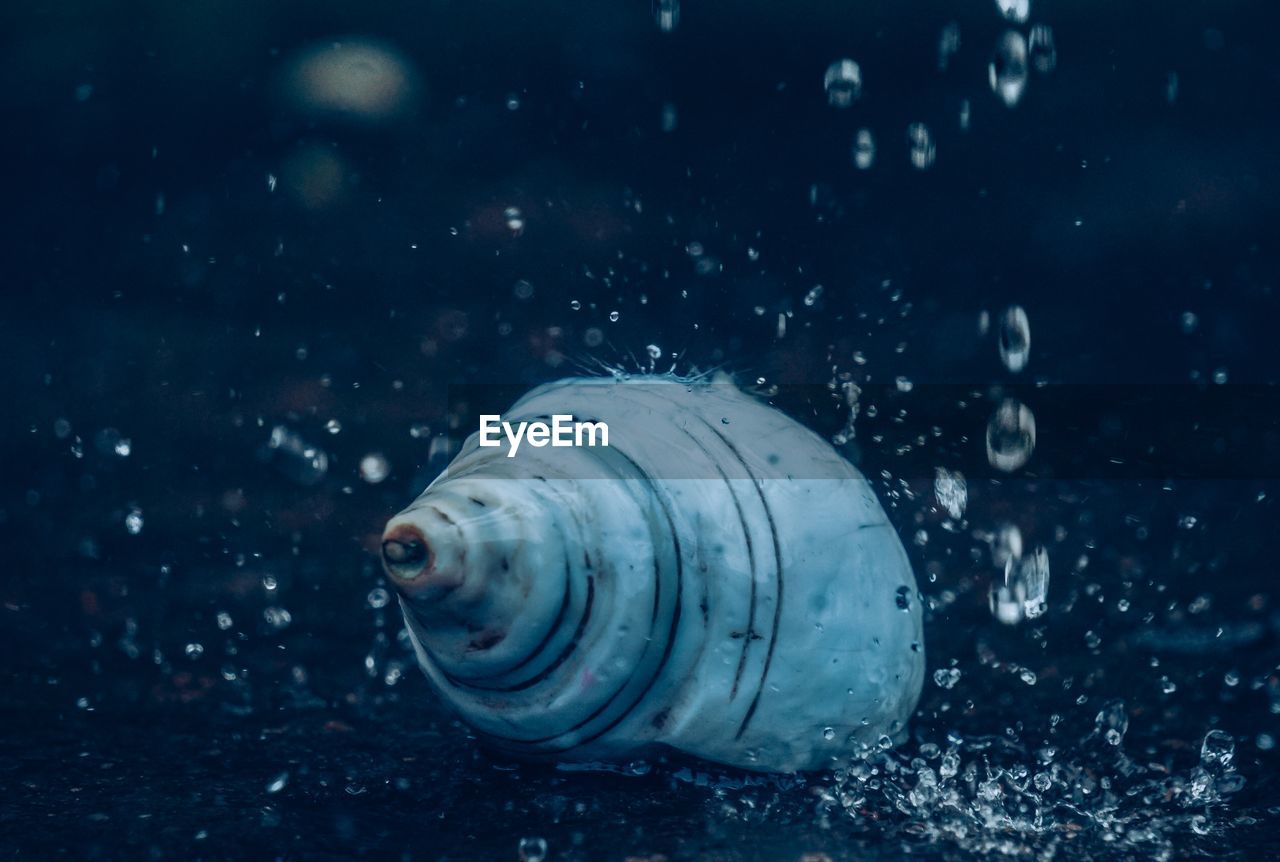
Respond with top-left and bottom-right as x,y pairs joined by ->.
383,378 -> 924,771
